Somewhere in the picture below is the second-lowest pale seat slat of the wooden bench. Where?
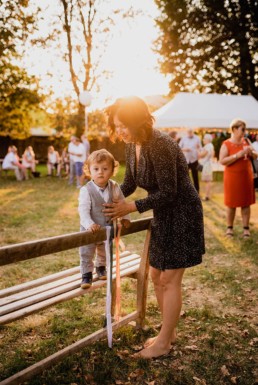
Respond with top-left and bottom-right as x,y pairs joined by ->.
0,258 -> 139,316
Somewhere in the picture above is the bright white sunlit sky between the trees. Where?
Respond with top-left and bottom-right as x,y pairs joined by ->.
24,0 -> 169,109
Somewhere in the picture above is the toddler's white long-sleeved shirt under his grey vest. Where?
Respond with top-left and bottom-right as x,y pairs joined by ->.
78,179 -> 130,230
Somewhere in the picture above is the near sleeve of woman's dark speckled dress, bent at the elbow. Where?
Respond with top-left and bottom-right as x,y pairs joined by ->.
135,138 -> 179,213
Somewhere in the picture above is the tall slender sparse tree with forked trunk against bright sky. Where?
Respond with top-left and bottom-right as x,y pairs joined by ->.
55,0 -> 137,136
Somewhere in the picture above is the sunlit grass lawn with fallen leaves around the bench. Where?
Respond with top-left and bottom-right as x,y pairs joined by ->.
0,167 -> 258,385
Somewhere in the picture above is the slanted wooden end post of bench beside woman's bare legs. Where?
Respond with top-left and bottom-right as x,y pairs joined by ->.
136,228 -> 151,328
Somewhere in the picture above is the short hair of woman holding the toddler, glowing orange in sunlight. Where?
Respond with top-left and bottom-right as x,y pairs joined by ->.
105,96 -> 154,143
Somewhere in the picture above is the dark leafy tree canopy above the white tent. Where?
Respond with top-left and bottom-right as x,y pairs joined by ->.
155,0 -> 258,100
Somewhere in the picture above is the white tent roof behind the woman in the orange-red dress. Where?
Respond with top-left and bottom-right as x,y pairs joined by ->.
153,92 -> 258,129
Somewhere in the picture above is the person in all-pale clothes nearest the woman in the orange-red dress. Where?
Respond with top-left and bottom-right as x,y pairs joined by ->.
198,134 -> 214,201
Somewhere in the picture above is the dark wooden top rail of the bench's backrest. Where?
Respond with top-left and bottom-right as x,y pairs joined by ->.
0,218 -> 151,266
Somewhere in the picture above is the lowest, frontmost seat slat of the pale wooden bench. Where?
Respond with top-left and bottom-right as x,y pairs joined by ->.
0,265 -> 141,325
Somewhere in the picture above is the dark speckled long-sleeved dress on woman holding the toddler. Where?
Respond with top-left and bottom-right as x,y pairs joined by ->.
121,130 -> 205,270
